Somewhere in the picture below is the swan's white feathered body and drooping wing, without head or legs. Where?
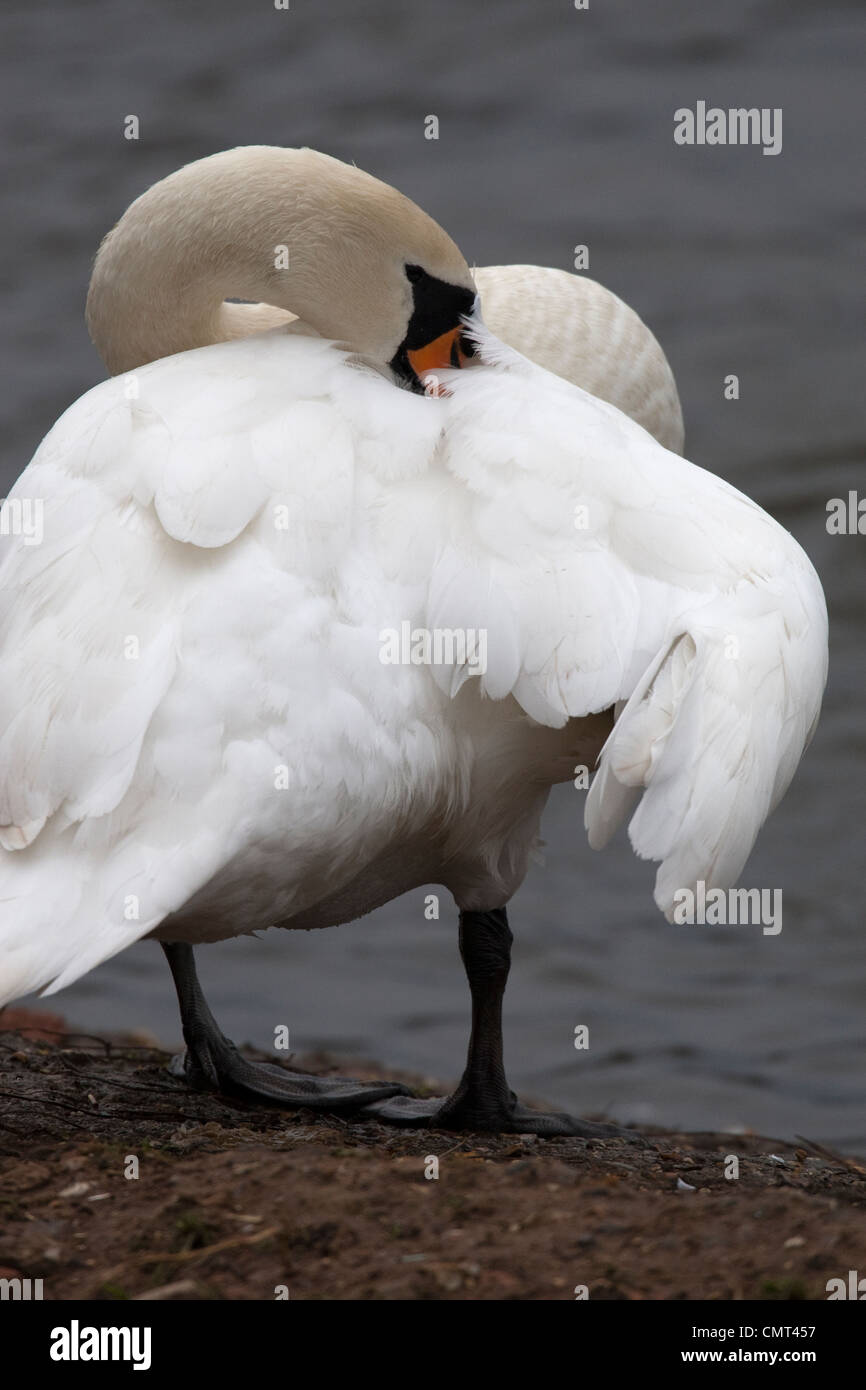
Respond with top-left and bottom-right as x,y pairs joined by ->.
0,318 -> 827,1002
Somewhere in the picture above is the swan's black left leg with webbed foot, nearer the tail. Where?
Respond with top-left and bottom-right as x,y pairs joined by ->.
163,942 -> 409,1111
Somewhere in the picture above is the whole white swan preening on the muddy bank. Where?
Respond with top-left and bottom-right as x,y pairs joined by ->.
0,147 -> 827,1136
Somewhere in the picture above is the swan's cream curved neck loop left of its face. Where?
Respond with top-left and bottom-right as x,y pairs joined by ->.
86,146 -> 339,374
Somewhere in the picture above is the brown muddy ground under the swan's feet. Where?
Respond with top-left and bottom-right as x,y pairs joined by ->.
0,1011 -> 866,1300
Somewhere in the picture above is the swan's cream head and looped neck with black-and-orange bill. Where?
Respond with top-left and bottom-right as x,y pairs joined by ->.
88,146 -> 478,391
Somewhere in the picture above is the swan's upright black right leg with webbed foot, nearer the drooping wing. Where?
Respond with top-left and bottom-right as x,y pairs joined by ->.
364,908 -> 637,1138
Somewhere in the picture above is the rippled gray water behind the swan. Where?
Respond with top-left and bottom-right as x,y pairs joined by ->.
0,0 -> 866,1150
